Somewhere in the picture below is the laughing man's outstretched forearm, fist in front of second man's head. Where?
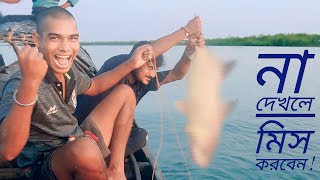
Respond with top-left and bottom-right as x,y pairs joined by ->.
84,45 -> 153,96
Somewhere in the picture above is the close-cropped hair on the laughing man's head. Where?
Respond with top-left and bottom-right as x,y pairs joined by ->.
36,6 -> 75,36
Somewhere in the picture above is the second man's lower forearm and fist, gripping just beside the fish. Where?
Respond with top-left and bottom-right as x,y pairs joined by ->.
160,34 -> 205,85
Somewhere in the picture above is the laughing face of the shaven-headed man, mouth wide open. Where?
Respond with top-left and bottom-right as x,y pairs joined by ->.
34,17 -> 80,77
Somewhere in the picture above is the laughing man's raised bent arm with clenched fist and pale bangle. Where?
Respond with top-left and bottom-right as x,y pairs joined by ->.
0,46 -> 48,161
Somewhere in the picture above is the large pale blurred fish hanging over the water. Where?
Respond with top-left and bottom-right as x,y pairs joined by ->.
176,47 -> 233,168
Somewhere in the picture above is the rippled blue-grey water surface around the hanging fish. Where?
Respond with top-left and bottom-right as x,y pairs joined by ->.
0,46 -> 320,179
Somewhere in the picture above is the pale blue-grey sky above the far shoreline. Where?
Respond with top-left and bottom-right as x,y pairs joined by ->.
0,0 -> 320,41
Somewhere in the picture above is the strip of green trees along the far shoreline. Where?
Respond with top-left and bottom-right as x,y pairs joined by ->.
81,34 -> 320,47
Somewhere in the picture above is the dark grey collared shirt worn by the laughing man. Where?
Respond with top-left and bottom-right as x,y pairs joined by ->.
0,66 -> 91,167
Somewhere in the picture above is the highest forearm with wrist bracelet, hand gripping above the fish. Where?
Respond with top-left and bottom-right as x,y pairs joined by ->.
151,17 -> 202,57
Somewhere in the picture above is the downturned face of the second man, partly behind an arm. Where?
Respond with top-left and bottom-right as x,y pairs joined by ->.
134,61 -> 157,85
